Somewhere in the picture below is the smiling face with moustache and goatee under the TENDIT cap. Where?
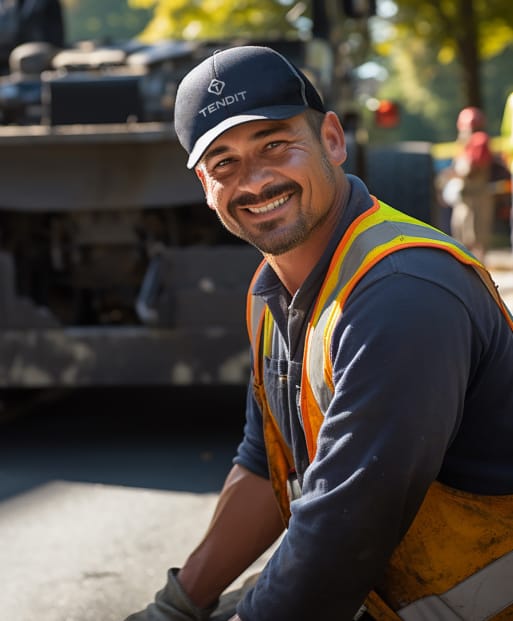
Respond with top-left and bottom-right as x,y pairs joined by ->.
196,114 -> 345,255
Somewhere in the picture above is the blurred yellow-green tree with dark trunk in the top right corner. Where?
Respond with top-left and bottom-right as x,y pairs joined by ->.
370,0 -> 513,142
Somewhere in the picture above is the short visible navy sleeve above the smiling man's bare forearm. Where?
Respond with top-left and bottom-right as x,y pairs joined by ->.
233,381 -> 269,479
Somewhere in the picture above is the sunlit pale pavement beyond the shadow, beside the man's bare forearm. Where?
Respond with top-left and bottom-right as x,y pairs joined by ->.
0,481 -> 274,621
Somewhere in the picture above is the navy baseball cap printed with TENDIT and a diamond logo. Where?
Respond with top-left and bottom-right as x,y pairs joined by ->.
174,45 -> 325,168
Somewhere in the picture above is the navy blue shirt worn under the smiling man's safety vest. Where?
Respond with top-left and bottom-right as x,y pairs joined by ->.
234,177 -> 513,621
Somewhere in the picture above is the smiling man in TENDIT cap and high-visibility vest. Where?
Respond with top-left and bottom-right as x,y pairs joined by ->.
124,46 -> 513,621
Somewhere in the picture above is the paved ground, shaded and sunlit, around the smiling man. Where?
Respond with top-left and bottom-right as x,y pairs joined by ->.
0,251 -> 513,621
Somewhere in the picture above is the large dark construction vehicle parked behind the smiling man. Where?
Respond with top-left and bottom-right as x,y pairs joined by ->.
0,2 -> 432,389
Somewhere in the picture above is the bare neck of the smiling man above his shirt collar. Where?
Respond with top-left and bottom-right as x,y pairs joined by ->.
264,177 -> 349,296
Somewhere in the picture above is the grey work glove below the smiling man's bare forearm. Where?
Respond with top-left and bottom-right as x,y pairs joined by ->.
125,567 -> 217,621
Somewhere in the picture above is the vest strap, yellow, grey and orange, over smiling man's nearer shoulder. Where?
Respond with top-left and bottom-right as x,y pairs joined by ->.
301,197 -> 513,457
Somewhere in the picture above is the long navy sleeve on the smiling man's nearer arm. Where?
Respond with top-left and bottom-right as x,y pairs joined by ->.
239,273 -> 472,621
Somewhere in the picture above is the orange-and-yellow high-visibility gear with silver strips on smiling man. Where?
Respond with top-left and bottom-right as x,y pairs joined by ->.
246,199 -> 513,621
